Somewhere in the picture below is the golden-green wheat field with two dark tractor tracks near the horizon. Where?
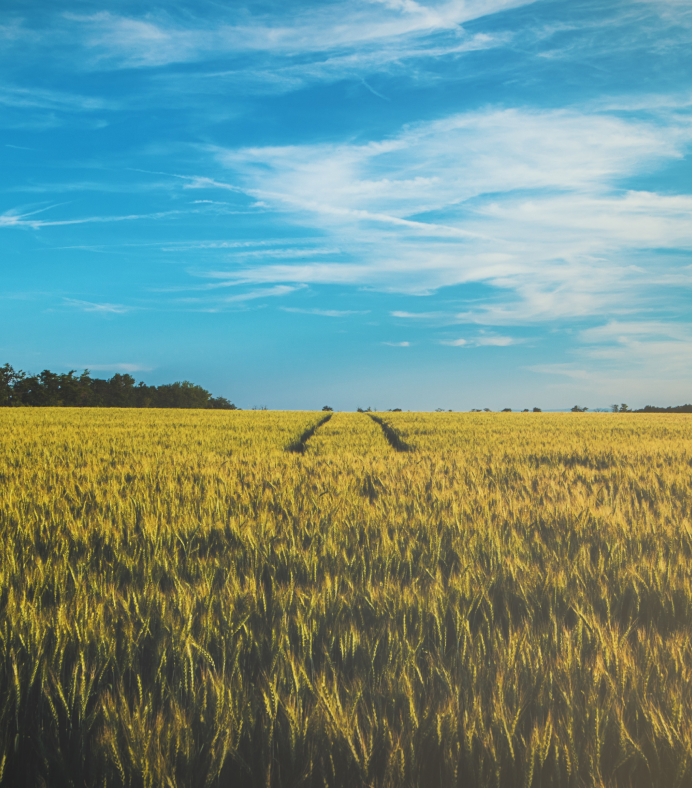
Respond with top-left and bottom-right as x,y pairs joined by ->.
0,408 -> 692,788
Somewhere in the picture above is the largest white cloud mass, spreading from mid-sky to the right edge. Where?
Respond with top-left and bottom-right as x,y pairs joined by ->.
201,104 -> 692,318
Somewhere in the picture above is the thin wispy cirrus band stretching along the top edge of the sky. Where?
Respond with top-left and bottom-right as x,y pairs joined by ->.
0,0 -> 691,80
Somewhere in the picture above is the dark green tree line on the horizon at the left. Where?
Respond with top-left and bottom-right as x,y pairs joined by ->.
0,364 -> 236,410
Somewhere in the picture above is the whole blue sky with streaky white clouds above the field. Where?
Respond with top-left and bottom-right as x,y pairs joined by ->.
0,0 -> 692,410
